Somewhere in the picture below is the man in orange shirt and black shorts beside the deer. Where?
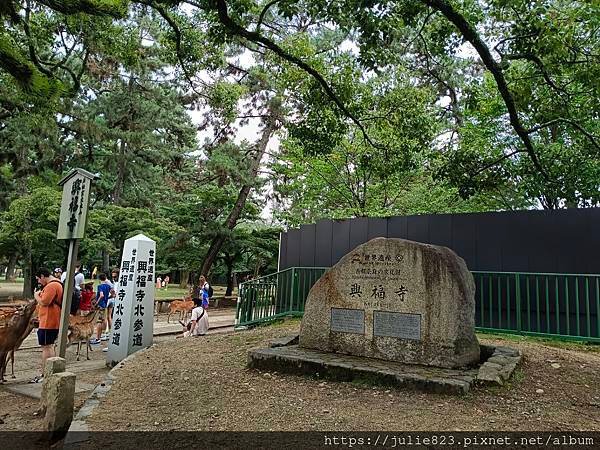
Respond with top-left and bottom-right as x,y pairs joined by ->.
31,268 -> 63,383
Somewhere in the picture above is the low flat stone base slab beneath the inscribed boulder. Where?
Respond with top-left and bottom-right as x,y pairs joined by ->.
248,338 -> 521,395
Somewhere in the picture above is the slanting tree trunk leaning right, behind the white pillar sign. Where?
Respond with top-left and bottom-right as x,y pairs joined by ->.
200,118 -> 280,276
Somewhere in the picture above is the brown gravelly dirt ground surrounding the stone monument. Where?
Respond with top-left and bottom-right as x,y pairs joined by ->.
78,321 -> 600,431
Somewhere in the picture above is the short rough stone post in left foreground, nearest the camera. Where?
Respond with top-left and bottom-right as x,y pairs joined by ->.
44,372 -> 75,437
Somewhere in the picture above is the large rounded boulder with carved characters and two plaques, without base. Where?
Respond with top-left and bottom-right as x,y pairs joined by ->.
300,238 -> 479,368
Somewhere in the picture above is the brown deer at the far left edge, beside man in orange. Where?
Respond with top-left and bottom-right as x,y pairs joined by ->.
0,300 -> 37,382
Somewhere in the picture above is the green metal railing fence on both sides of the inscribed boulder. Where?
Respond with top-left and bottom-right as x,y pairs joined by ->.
236,267 -> 600,343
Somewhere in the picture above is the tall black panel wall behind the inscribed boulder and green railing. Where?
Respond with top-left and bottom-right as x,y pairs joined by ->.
279,208 -> 600,339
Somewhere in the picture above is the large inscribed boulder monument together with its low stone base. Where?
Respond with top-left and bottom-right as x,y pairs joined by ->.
248,238 -> 521,394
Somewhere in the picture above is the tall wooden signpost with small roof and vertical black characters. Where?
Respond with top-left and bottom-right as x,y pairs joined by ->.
56,169 -> 98,358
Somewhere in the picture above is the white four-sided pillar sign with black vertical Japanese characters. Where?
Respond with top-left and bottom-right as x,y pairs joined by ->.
107,234 -> 156,366
